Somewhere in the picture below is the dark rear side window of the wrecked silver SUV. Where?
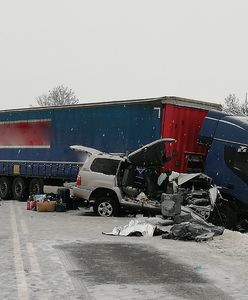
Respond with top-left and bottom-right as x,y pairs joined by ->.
90,158 -> 120,175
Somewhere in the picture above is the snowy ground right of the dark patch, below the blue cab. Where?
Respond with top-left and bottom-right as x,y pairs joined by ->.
147,226 -> 248,299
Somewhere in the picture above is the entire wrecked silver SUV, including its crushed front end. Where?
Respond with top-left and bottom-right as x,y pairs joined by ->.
70,138 -> 234,228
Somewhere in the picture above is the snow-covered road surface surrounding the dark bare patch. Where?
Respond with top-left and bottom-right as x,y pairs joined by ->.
0,201 -> 248,300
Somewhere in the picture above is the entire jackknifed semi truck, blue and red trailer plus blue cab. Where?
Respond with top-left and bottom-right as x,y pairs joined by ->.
0,97 -> 248,223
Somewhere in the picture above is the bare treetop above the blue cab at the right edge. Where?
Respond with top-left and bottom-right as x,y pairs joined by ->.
223,94 -> 245,116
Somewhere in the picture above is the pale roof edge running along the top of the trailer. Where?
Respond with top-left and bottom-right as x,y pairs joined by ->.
0,96 -> 222,113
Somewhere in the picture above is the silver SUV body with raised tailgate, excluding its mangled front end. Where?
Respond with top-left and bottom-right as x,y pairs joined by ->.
70,138 -> 175,217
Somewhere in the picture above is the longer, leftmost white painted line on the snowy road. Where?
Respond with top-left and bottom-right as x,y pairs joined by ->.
10,202 -> 29,300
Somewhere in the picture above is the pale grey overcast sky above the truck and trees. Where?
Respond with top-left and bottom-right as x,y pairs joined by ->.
0,0 -> 248,109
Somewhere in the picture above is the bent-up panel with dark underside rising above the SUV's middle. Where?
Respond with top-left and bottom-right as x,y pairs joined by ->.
127,138 -> 176,167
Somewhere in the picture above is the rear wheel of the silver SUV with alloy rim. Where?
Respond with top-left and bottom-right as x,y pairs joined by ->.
93,197 -> 119,217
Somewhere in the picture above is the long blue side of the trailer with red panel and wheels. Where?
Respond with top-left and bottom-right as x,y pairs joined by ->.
0,99 -> 169,200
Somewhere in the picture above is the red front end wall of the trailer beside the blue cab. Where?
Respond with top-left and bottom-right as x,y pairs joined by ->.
161,97 -> 221,173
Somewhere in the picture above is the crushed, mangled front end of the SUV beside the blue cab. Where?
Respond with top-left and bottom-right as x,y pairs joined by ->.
161,172 -> 237,229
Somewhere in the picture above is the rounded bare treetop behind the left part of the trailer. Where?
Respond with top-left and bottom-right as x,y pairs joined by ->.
35,85 -> 79,106
